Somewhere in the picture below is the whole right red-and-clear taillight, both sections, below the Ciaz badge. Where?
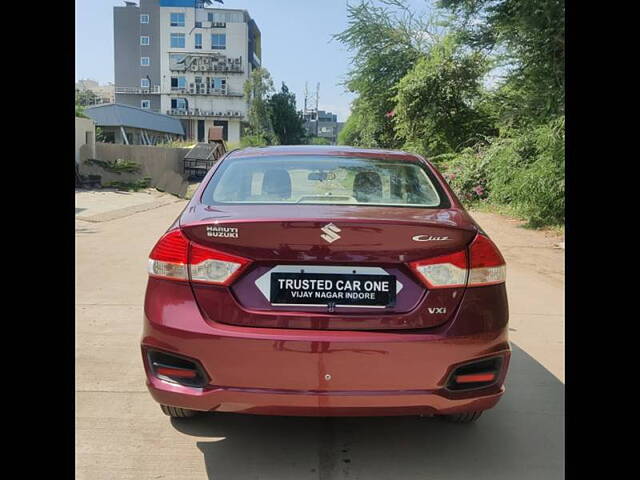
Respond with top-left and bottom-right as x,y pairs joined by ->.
409,233 -> 506,289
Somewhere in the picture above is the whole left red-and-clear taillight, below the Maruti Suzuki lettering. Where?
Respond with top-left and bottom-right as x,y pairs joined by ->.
149,229 -> 251,285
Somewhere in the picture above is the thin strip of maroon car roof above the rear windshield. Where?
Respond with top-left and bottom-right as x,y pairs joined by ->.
229,145 -> 416,160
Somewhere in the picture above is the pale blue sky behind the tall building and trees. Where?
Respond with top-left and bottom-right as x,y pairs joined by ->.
76,0 -> 426,121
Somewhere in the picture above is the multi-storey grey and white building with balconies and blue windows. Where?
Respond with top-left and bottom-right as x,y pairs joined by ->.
114,0 -> 261,142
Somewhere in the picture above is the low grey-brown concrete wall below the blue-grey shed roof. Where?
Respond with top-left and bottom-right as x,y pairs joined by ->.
80,143 -> 189,197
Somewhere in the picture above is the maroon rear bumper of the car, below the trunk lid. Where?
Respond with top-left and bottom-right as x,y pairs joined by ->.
142,286 -> 510,416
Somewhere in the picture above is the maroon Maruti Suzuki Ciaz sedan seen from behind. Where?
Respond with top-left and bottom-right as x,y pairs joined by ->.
142,146 -> 510,423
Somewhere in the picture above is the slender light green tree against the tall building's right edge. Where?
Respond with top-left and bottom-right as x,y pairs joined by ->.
244,68 -> 277,145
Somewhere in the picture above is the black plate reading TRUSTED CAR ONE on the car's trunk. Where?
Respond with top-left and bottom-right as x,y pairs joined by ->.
270,272 -> 396,307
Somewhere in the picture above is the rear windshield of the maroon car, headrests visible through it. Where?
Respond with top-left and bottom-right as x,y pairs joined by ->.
202,155 -> 444,207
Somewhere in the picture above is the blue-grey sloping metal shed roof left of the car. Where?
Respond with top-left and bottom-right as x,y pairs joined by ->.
84,103 -> 184,135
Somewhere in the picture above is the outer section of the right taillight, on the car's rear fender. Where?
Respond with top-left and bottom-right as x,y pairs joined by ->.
468,233 -> 507,287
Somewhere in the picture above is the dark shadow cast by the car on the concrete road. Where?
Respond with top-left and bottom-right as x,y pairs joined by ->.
172,345 -> 564,480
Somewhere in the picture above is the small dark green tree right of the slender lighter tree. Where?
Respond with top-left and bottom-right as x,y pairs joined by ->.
268,82 -> 305,145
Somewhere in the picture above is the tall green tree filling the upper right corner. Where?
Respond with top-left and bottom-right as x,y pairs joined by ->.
439,0 -> 565,126
